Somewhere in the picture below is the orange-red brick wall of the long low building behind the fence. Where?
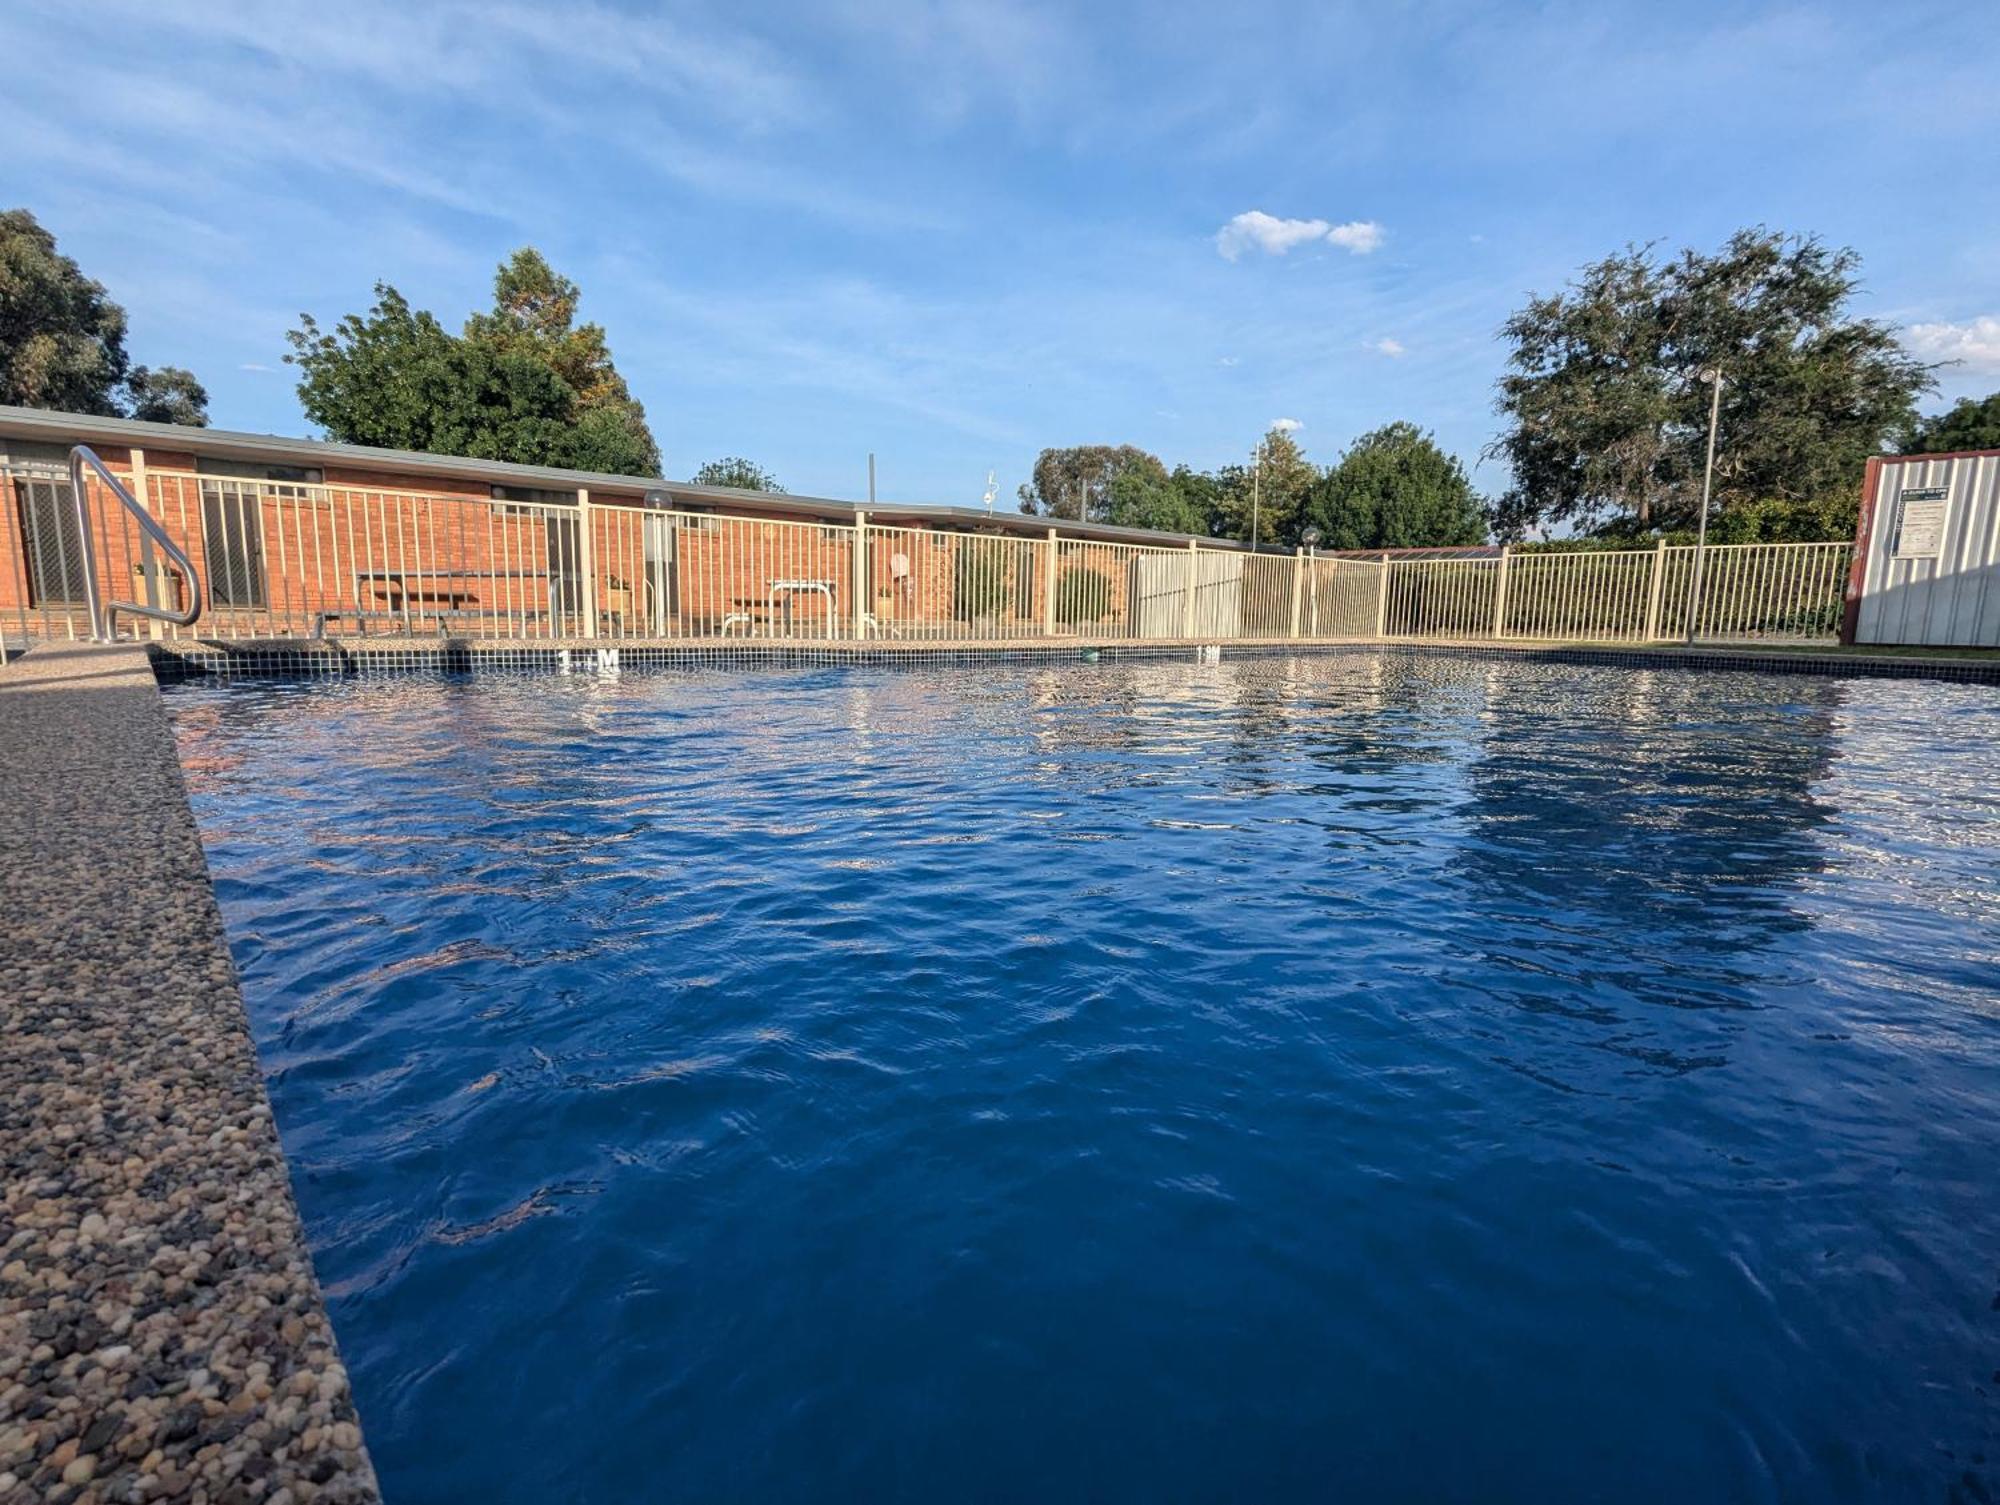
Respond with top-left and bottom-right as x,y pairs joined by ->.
0,446 -> 1168,636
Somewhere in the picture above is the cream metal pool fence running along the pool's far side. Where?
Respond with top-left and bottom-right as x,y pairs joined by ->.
0,464 -> 1850,642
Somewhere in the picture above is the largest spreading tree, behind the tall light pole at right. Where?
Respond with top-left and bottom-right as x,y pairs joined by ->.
1490,228 -> 1934,536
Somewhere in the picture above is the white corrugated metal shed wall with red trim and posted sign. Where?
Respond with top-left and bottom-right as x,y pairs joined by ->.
1854,454 -> 2000,648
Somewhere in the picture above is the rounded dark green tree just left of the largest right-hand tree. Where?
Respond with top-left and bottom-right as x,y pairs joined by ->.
1306,422 -> 1486,548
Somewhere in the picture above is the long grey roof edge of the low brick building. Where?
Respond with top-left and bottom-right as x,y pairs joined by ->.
0,404 -> 1286,552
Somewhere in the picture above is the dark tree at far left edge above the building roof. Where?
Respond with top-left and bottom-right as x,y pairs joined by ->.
0,208 -> 208,426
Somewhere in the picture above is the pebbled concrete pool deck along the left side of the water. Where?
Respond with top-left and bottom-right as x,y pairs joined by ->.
0,644 -> 378,1505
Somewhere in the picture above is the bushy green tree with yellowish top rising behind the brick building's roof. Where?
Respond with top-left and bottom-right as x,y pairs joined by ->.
286,250 -> 660,476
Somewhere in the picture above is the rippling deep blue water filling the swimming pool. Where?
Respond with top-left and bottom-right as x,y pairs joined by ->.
170,654 -> 2000,1503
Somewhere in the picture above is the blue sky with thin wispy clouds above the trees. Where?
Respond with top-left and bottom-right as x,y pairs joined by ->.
0,0 -> 2000,504
